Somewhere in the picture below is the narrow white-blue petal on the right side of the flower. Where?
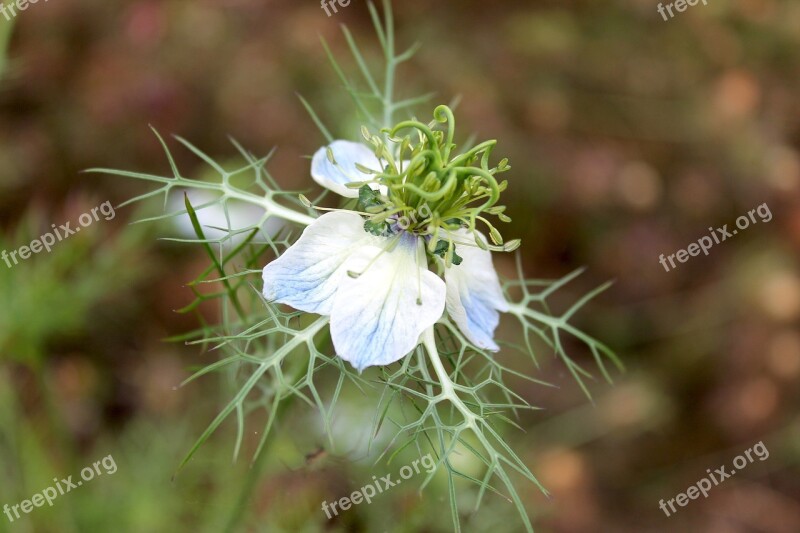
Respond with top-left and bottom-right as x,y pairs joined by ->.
444,230 -> 508,352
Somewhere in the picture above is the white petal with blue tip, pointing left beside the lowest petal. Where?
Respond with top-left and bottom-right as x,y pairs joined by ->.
264,211 -> 382,315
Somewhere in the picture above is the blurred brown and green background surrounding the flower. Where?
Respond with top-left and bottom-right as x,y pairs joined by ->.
0,0 -> 800,532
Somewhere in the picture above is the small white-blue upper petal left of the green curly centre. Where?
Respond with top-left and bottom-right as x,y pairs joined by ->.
311,141 -> 381,198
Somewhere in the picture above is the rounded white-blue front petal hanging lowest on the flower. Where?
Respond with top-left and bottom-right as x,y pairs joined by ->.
331,235 -> 446,371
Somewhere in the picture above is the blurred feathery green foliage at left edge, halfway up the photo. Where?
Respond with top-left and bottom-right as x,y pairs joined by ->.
0,210 -> 147,367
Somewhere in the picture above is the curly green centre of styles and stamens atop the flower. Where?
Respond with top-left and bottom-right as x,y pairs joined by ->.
353,105 -> 520,266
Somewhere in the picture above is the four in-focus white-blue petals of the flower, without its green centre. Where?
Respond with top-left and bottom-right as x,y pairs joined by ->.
264,141 -> 508,371
